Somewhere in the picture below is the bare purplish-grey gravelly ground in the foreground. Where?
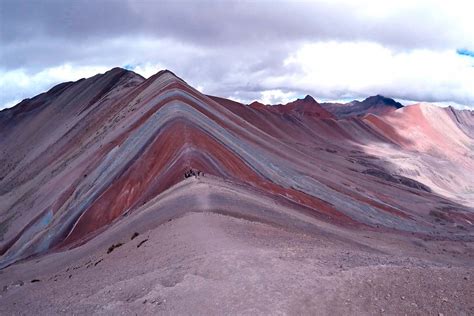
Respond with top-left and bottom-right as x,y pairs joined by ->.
0,212 -> 474,315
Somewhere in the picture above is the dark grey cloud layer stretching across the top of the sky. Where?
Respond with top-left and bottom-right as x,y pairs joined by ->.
1,0 -> 468,68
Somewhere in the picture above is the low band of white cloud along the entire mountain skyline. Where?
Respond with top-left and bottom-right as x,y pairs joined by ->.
0,40 -> 474,108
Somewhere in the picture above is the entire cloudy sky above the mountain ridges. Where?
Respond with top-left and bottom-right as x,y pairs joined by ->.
0,0 -> 474,109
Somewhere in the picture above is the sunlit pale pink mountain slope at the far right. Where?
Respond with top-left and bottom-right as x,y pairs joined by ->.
363,104 -> 474,207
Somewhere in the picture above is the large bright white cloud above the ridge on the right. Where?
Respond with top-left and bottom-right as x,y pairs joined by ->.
269,41 -> 474,105
